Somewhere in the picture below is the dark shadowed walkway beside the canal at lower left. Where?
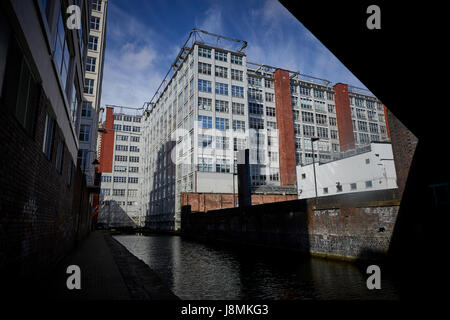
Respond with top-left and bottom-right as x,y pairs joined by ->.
22,231 -> 178,300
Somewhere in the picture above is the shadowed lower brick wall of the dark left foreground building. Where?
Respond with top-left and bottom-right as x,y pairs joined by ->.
0,89 -> 90,276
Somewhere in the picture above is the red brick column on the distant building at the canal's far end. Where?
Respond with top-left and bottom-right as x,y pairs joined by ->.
99,107 -> 114,172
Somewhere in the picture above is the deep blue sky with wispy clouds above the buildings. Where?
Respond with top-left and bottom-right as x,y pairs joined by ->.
102,0 -> 365,107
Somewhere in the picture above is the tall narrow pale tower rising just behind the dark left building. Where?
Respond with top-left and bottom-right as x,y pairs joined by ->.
78,0 -> 108,185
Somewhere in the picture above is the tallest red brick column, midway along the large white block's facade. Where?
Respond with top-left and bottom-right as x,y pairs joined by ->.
274,69 -> 297,186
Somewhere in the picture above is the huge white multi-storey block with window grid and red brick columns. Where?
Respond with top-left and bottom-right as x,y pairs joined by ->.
142,34 -> 388,229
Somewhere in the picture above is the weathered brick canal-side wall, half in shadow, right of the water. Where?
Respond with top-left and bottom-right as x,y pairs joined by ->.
181,190 -> 399,260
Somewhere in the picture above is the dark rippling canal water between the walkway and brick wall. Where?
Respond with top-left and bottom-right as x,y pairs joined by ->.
115,235 -> 399,300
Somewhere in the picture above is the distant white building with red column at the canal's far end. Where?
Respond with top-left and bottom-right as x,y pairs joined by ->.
98,107 -> 144,227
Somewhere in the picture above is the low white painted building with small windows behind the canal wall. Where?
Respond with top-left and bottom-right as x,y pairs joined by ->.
297,142 -> 397,199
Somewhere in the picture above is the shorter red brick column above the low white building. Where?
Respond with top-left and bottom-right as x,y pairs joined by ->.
333,83 -> 355,151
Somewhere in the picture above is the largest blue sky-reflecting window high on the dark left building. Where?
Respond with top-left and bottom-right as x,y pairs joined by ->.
53,12 -> 70,91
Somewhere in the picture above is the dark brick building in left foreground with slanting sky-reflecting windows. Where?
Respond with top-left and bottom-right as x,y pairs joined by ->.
0,0 -> 96,278
